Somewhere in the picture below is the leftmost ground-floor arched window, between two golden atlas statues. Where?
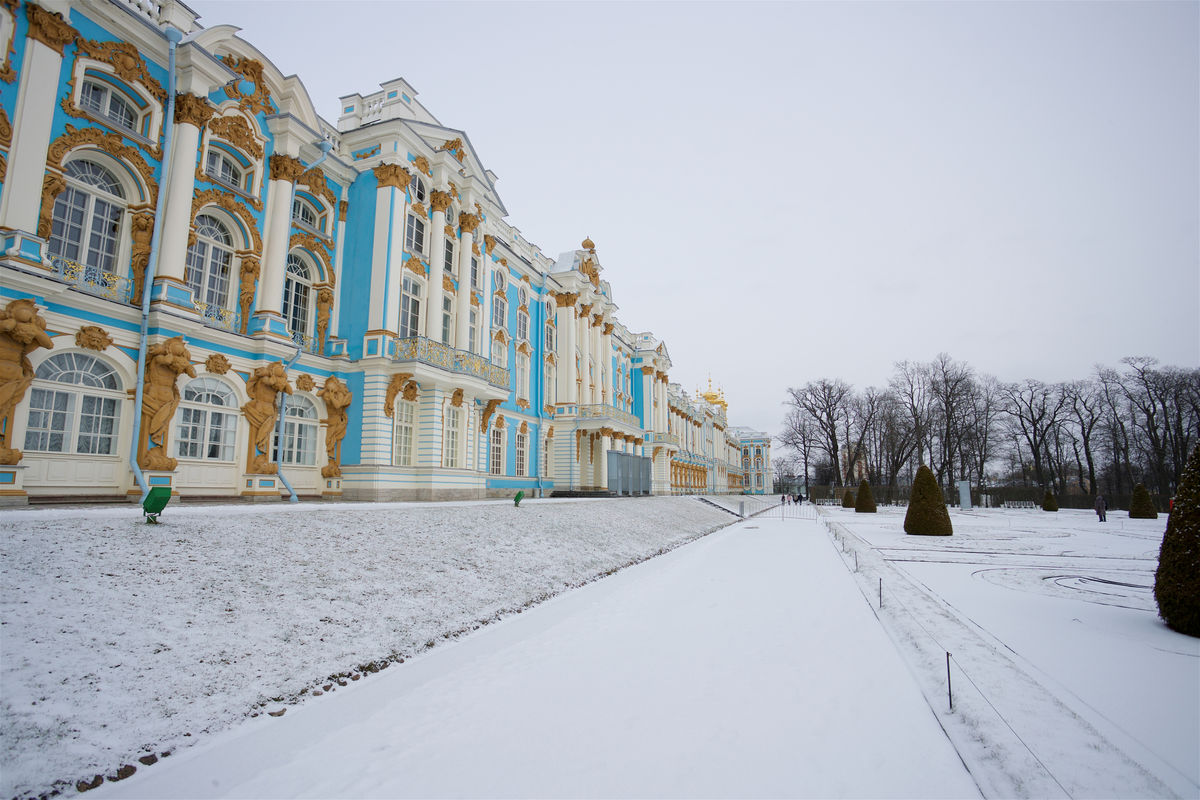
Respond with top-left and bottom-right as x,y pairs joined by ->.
25,353 -> 125,456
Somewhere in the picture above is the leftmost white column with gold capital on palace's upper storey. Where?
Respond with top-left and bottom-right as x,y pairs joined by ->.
0,2 -> 76,234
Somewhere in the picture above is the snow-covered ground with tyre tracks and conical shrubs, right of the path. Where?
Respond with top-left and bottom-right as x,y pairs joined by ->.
821,507 -> 1200,798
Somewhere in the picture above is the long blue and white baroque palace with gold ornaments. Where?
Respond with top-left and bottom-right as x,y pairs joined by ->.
0,0 -> 769,503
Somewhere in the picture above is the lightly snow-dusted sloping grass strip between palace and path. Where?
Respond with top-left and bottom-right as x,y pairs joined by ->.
0,498 -> 734,798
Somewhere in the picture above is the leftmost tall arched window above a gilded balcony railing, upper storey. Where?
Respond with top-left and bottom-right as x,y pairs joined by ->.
49,161 -> 125,272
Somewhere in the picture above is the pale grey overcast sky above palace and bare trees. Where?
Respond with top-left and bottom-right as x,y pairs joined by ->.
187,0 -> 1200,434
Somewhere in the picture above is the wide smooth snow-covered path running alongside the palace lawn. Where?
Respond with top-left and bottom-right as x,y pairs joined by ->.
96,519 -> 978,800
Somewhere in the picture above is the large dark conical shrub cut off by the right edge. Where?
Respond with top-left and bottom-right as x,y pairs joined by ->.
1152,444 -> 1200,637
